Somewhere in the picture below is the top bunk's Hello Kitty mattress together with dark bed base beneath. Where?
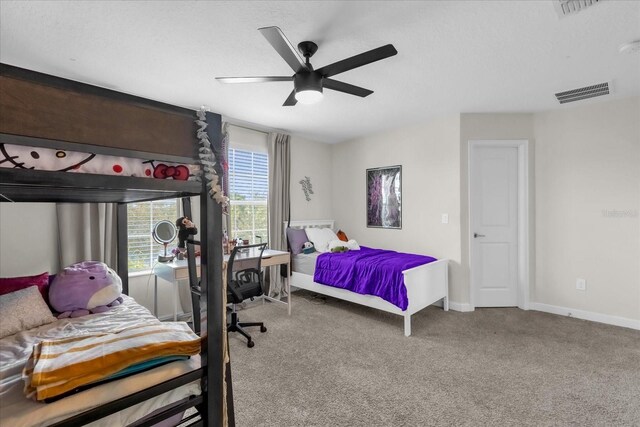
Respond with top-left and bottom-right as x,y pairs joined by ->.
0,134 -> 202,203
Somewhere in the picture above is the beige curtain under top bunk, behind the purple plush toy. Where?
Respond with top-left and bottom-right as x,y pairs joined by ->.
56,203 -> 117,270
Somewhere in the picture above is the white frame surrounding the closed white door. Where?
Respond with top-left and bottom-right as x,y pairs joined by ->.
467,139 -> 530,310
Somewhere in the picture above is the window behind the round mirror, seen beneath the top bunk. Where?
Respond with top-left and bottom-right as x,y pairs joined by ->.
127,199 -> 180,273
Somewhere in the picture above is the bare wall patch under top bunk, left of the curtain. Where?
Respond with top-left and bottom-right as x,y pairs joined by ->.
0,203 -> 59,277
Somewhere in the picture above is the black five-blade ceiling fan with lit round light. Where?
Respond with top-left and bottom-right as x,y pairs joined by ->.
216,27 -> 398,106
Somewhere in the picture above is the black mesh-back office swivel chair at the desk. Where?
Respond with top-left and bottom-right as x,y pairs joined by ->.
227,243 -> 267,348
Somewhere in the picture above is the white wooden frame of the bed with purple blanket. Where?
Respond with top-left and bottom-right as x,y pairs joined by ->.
284,220 -> 449,337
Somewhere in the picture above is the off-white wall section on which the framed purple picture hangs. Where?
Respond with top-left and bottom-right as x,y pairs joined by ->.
331,115 -> 466,301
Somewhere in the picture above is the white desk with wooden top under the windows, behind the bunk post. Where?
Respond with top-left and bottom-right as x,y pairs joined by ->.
153,249 -> 291,322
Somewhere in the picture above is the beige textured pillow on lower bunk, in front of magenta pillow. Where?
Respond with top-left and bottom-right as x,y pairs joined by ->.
0,286 -> 56,338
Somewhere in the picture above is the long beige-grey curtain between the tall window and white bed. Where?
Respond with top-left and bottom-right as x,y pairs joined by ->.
267,133 -> 291,298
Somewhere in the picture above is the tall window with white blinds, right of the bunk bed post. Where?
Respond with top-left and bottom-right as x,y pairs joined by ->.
229,147 -> 269,243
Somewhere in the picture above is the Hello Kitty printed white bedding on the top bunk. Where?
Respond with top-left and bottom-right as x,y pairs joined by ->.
0,143 -> 200,181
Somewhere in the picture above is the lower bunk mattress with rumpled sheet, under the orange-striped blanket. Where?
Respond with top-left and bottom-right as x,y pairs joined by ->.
0,295 -> 200,427
